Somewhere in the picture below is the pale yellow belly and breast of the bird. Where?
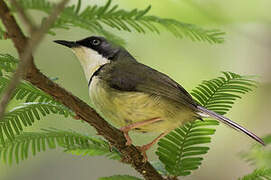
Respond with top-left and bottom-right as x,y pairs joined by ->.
89,77 -> 196,132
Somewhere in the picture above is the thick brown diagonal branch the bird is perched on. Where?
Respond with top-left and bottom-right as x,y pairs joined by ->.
0,0 -> 166,180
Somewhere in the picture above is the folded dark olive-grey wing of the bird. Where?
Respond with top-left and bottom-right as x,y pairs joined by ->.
102,62 -> 197,109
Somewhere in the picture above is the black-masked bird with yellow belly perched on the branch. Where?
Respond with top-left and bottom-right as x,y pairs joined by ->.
54,36 -> 264,159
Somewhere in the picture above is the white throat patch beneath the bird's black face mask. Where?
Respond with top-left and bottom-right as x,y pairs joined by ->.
72,46 -> 110,81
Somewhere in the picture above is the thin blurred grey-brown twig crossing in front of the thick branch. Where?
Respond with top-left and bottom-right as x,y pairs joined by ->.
0,0 -> 68,124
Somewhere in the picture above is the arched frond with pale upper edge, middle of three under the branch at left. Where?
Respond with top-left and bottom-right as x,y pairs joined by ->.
0,102 -> 72,144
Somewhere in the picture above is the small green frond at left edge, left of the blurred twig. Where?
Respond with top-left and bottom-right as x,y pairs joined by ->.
0,53 -> 19,76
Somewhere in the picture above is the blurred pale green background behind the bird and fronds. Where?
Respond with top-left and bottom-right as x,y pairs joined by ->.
0,0 -> 271,180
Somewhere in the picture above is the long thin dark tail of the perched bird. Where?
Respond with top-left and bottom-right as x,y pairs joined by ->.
197,106 -> 265,145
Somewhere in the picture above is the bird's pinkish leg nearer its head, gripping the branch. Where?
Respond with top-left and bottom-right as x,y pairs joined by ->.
120,118 -> 161,146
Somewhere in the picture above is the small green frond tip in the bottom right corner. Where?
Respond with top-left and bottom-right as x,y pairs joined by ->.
238,168 -> 271,180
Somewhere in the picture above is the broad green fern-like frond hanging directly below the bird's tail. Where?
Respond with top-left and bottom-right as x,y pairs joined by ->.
156,120 -> 218,176
